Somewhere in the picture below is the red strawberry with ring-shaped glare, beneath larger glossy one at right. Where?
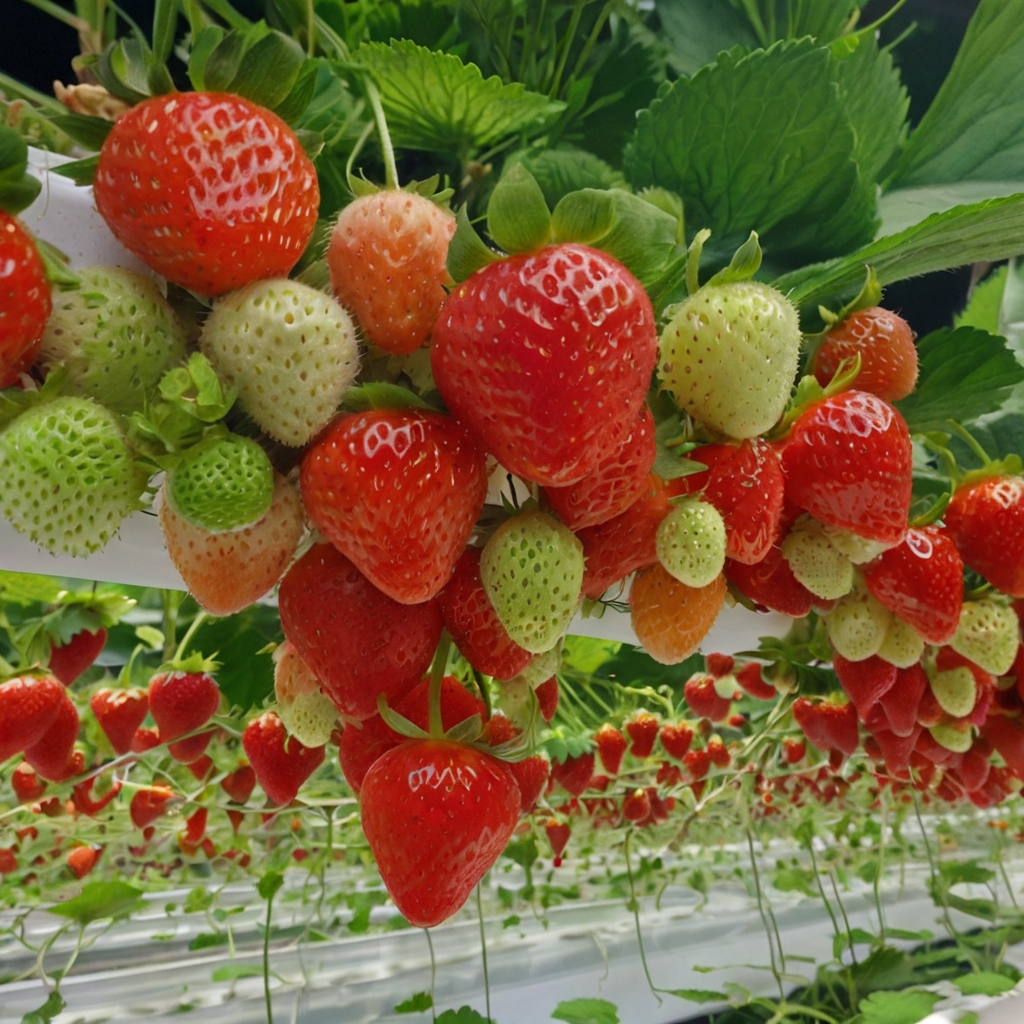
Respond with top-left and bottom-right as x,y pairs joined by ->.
864,526 -> 964,644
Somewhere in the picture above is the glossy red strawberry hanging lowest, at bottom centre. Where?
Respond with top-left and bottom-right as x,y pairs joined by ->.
359,739 -> 520,928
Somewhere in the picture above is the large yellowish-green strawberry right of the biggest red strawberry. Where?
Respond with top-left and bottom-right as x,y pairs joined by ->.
658,281 -> 801,438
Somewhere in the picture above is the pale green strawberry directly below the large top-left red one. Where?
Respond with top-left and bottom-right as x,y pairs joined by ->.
40,266 -> 187,415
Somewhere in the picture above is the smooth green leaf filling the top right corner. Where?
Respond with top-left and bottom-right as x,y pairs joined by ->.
893,0 -> 1024,186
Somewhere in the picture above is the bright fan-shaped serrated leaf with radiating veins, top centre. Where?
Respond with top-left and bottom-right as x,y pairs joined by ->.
354,40 -> 565,157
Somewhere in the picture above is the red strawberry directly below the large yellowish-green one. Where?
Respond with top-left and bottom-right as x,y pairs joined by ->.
669,437 -> 784,565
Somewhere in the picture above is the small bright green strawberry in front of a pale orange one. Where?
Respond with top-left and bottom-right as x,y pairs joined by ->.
167,434 -> 273,532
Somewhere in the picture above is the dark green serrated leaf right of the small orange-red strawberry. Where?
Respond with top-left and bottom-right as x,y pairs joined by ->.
896,328 -> 1024,433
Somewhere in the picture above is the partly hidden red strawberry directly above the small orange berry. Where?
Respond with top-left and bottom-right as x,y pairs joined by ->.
578,475 -> 672,600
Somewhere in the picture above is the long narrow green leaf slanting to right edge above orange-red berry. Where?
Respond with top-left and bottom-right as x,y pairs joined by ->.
772,195 -> 1024,306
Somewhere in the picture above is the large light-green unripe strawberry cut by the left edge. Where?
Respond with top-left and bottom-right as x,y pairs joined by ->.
0,397 -> 146,557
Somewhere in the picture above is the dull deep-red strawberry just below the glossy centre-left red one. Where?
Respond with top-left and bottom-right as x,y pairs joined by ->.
278,544 -> 443,721
